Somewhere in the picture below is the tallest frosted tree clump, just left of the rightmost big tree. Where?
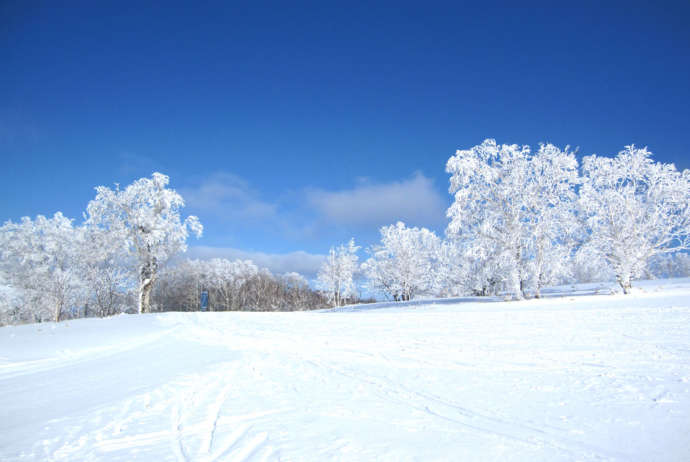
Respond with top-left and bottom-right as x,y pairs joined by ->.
446,139 -> 577,298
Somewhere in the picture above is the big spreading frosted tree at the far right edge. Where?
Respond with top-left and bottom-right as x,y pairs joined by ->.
580,145 -> 690,293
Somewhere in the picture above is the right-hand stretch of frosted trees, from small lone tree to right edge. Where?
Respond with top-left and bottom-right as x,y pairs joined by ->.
318,139 -> 690,305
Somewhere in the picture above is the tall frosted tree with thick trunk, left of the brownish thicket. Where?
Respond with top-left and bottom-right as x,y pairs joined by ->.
86,173 -> 203,313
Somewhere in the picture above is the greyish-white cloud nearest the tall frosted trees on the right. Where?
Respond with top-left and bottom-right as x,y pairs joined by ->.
307,173 -> 447,226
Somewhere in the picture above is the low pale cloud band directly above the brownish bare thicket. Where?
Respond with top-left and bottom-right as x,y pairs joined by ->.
185,246 -> 325,279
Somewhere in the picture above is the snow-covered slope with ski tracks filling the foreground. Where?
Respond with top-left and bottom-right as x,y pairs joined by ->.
0,279 -> 690,461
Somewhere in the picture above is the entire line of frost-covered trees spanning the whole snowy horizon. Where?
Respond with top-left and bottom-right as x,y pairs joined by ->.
5,139 -> 690,324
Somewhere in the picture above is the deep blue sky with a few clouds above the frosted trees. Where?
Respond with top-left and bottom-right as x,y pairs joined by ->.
0,1 -> 690,272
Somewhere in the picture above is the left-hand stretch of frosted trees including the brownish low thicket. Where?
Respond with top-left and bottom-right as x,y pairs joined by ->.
0,173 -> 325,325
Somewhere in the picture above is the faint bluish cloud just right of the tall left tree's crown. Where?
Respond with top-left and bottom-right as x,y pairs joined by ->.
178,172 -> 277,220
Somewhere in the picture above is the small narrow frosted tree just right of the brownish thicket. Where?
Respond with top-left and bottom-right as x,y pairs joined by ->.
316,239 -> 359,306
